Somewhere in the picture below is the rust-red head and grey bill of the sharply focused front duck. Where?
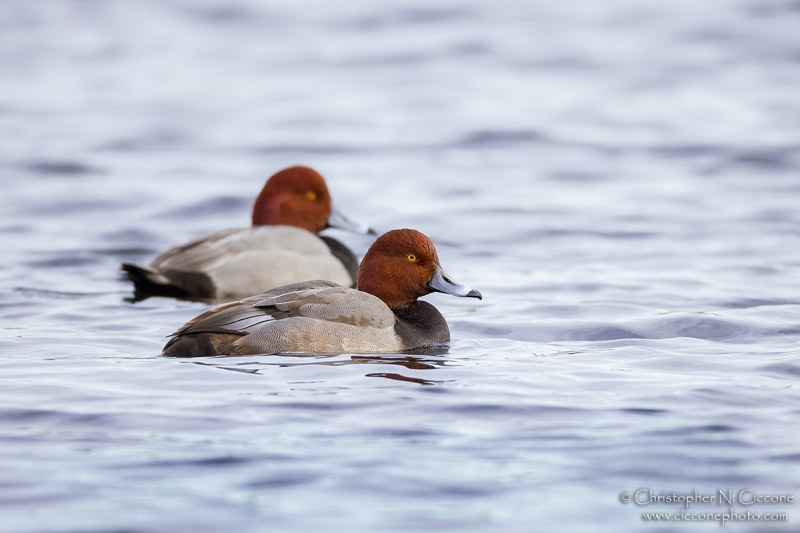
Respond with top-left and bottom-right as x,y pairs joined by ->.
358,229 -> 481,309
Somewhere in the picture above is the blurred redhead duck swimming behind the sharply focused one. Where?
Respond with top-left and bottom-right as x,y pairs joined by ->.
122,166 -> 372,298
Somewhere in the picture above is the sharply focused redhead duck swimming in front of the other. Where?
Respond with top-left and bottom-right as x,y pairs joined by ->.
162,229 -> 481,357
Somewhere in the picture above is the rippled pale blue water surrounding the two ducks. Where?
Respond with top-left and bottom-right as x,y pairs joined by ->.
0,0 -> 800,533
